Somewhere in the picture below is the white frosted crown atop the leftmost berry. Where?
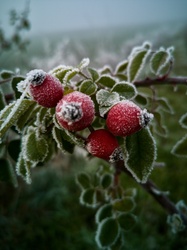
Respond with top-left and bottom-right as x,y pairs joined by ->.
26,69 -> 46,86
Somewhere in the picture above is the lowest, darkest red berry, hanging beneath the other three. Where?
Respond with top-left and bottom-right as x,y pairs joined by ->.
86,129 -> 121,161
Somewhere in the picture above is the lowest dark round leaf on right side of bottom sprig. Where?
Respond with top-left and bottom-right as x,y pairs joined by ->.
118,213 -> 137,231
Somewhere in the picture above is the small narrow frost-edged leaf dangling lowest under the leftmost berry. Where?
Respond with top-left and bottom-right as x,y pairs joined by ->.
16,152 -> 32,184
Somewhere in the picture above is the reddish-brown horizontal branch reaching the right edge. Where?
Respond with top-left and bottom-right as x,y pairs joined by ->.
134,76 -> 187,87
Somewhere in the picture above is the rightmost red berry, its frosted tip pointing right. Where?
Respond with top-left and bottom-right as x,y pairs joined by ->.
106,101 -> 153,136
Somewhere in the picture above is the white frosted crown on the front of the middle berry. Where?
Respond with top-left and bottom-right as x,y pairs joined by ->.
57,101 -> 83,125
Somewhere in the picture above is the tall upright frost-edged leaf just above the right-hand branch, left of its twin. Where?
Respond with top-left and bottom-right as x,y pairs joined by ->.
127,49 -> 150,82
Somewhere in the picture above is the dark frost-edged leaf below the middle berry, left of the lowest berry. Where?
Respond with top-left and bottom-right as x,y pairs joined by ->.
52,127 -> 74,154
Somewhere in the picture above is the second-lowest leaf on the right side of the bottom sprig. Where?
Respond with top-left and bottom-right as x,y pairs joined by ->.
113,197 -> 135,212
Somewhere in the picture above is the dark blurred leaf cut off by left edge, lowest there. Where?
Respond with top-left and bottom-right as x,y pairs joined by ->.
0,159 -> 18,187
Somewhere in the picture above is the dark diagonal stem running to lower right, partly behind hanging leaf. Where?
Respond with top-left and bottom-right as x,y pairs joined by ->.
115,161 -> 187,226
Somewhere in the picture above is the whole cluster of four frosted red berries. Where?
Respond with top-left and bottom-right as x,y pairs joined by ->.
24,70 -> 153,161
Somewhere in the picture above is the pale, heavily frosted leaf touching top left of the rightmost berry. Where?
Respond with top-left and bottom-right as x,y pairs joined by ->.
96,89 -> 120,107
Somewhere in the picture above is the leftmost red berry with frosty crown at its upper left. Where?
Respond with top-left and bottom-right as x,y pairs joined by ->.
25,69 -> 64,108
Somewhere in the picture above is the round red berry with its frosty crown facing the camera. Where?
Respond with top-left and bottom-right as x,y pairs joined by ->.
56,91 -> 95,131
